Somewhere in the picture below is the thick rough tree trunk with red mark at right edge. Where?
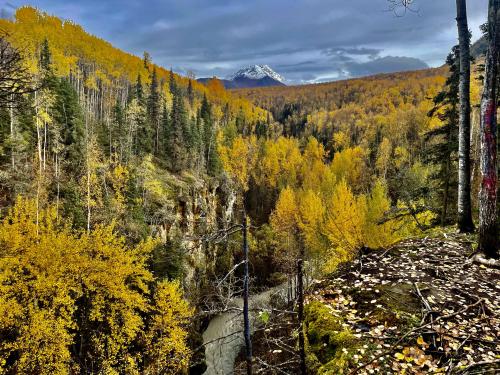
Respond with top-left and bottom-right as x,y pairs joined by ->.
478,0 -> 500,258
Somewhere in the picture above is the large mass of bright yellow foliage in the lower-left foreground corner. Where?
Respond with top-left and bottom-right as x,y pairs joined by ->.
0,198 -> 192,374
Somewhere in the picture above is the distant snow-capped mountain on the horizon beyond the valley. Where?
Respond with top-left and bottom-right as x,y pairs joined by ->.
198,65 -> 286,89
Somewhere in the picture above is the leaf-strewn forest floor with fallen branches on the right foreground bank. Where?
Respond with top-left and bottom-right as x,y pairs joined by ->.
306,234 -> 500,374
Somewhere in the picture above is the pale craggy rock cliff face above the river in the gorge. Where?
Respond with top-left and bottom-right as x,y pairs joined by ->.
151,176 -> 241,294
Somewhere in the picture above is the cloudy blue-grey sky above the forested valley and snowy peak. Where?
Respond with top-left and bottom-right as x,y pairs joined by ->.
0,0 -> 487,83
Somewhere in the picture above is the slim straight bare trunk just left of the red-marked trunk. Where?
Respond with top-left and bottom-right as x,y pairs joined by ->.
456,0 -> 474,233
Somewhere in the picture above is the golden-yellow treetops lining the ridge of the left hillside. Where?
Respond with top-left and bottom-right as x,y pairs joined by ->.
0,6 -> 267,134
